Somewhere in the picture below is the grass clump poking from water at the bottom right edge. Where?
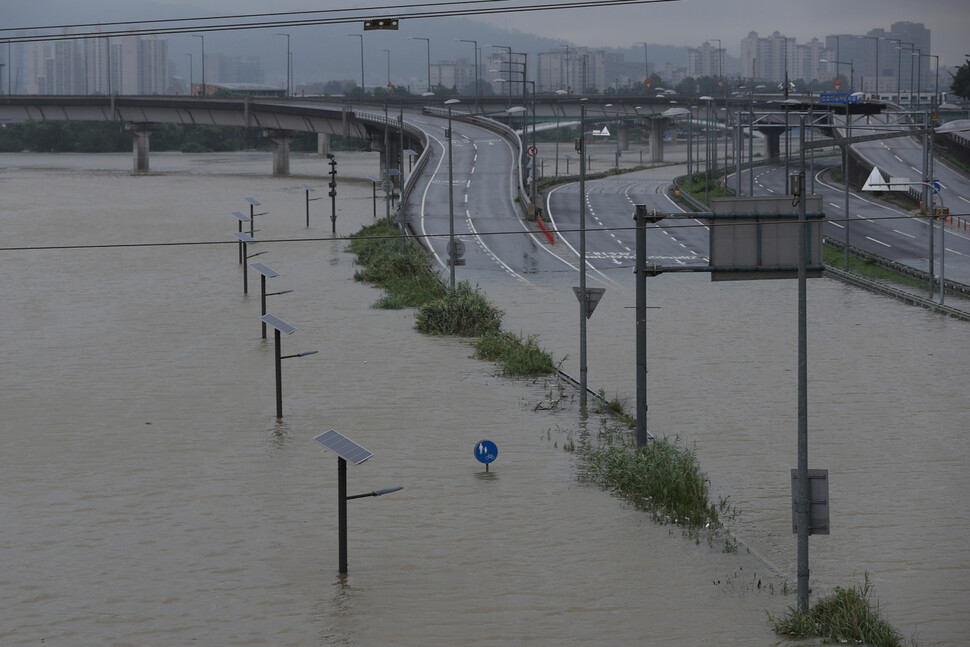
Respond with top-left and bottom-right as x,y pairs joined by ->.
768,573 -> 902,647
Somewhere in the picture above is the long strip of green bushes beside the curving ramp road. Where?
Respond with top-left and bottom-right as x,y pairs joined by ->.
347,221 -> 556,377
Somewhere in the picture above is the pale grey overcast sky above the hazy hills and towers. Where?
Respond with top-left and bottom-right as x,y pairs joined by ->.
9,0 -> 970,65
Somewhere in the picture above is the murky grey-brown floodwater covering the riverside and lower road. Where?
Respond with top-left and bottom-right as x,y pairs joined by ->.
0,154 -> 970,646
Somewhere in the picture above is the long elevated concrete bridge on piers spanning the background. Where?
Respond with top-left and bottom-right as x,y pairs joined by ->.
0,93 -> 885,175
